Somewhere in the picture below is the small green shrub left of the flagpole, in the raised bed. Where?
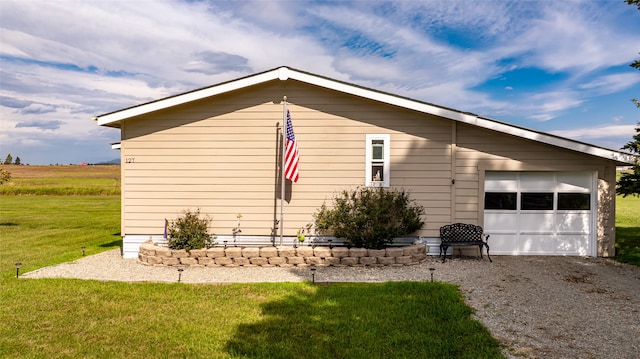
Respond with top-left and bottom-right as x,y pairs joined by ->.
167,209 -> 215,250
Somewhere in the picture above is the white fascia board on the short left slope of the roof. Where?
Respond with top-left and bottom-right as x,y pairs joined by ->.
97,69 -> 279,126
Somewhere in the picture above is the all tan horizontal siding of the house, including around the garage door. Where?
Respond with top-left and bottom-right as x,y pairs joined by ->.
116,76 -> 615,256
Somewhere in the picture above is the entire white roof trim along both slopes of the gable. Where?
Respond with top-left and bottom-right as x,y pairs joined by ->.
95,67 -> 635,164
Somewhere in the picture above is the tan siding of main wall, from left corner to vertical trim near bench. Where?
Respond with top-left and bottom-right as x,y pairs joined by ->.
121,81 -> 452,236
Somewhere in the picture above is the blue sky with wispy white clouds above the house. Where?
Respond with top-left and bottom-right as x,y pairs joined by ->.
0,0 -> 640,165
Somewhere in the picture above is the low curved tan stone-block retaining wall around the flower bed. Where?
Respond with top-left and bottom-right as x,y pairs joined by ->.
138,241 -> 427,267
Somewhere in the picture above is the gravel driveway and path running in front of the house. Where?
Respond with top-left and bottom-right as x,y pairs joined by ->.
21,250 -> 640,359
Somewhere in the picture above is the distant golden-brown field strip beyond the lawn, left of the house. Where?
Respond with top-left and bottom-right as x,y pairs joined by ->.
0,165 -> 120,196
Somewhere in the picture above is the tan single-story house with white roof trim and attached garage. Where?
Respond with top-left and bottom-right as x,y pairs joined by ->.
95,67 -> 633,257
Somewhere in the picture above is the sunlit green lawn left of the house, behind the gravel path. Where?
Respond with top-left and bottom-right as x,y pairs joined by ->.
0,196 -> 122,274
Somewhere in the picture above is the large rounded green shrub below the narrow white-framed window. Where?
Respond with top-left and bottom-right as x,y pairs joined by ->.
314,187 -> 424,249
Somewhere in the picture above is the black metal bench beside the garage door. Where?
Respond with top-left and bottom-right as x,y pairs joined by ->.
440,223 -> 493,263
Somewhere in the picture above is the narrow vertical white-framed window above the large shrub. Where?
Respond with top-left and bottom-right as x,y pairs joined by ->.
365,135 -> 390,187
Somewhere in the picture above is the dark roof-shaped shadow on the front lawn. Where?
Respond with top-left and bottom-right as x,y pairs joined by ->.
226,282 -> 502,358
